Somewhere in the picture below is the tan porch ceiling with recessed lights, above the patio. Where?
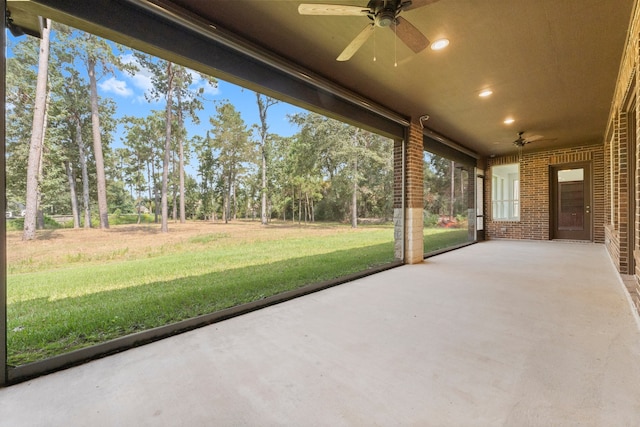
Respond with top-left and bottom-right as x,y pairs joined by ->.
9,0 -> 634,156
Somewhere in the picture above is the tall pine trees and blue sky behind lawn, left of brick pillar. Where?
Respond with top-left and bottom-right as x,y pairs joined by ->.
6,26 -> 400,231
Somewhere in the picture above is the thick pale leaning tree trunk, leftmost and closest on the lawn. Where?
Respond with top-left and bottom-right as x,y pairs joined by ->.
22,19 -> 51,240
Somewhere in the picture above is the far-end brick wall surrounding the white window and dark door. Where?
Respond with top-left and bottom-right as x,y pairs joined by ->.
484,145 -> 605,243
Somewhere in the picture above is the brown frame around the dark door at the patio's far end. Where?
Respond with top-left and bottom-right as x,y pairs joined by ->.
549,161 -> 593,242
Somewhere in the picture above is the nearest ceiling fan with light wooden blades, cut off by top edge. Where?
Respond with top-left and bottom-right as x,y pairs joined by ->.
298,0 -> 438,61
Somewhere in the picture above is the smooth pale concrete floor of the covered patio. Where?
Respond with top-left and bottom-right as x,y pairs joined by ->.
0,241 -> 640,427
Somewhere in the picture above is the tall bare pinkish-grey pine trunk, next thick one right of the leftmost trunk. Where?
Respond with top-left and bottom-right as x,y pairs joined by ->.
87,57 -> 109,229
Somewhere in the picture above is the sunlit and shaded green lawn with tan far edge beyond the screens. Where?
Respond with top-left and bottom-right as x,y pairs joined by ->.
7,223 -> 470,366
